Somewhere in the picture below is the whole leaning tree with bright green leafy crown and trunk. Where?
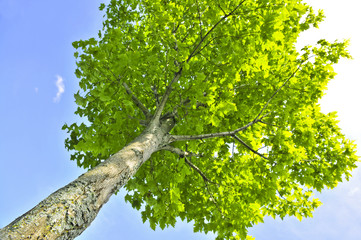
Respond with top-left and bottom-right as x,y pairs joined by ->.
0,0 -> 357,239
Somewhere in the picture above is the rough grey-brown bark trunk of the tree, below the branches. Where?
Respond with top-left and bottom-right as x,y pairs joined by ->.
0,121 -> 174,240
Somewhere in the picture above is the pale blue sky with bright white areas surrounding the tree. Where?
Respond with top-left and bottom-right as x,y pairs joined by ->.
0,0 -> 361,240
